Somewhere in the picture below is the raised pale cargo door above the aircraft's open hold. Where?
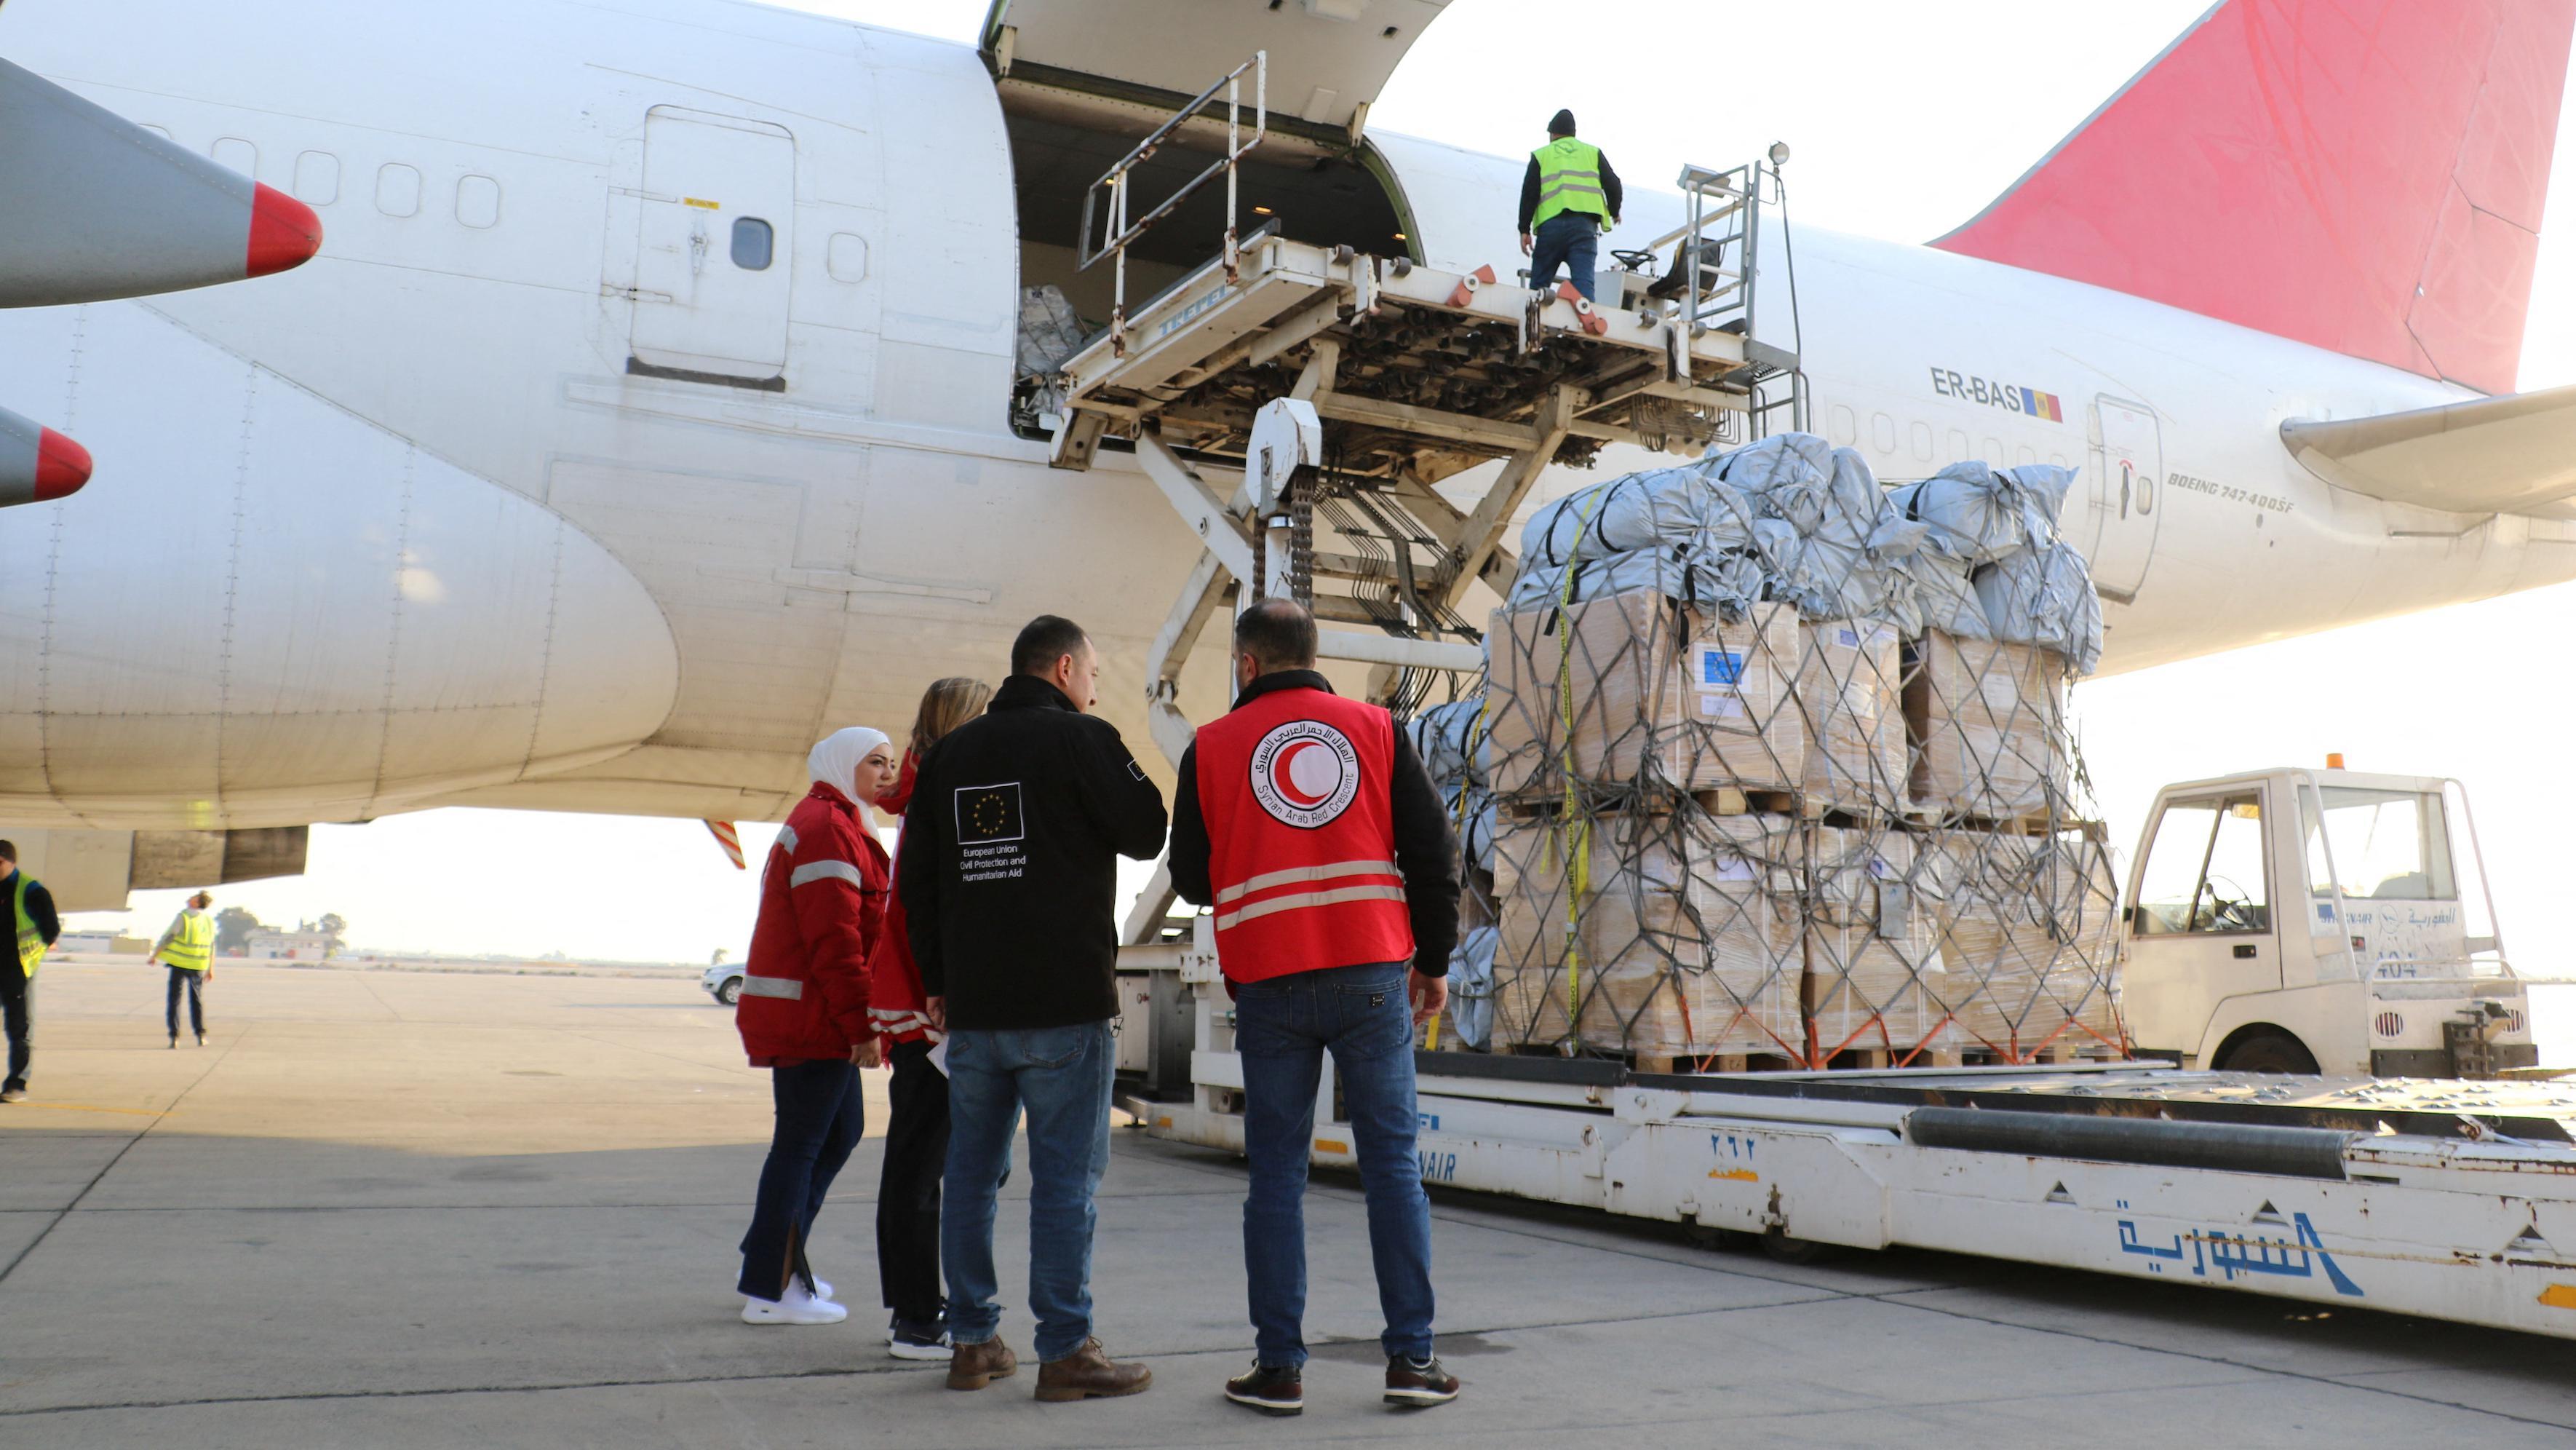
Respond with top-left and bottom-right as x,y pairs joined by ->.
984,0 -> 1447,147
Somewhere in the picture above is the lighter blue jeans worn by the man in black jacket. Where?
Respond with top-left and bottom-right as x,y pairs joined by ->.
940,1023 -> 1118,1360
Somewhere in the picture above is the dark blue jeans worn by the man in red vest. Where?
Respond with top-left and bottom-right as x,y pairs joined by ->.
1234,961 -> 1432,1368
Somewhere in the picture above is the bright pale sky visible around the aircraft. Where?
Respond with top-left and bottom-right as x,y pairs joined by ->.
65,0 -> 2576,976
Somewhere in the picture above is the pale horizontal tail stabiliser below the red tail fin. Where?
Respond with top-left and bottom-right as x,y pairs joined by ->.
2280,387 -> 2576,518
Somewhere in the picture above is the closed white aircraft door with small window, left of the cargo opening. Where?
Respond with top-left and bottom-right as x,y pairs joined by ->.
629,106 -> 796,389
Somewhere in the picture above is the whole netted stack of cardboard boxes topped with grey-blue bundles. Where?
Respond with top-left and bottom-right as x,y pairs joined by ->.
1409,435 -> 2126,1069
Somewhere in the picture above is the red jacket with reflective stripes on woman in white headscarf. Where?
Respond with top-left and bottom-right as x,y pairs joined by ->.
734,783 -> 891,1066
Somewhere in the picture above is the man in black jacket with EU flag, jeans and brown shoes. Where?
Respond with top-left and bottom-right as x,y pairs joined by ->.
897,616 -> 1164,1401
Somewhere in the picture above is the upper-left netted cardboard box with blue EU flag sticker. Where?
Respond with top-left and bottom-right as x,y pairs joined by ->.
1487,590 -> 1806,799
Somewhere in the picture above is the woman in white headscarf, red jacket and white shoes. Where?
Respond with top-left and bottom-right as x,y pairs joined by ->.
734,726 -> 897,1324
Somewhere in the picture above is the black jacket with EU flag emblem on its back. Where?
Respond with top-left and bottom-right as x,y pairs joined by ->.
897,675 -> 1164,1030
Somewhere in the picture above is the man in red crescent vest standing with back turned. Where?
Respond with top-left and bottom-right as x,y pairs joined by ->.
1169,600 -> 1458,1414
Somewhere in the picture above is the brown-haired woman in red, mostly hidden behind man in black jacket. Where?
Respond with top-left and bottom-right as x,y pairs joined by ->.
868,675 -> 992,1360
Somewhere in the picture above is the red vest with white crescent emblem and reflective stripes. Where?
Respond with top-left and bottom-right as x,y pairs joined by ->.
1198,690 -> 1414,981
